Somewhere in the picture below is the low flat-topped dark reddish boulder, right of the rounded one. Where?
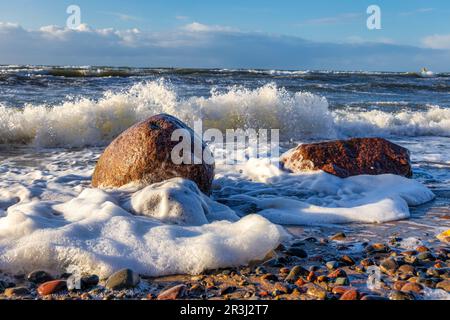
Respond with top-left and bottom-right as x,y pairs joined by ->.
281,138 -> 412,178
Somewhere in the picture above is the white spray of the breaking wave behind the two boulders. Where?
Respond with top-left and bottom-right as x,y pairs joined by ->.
0,80 -> 450,147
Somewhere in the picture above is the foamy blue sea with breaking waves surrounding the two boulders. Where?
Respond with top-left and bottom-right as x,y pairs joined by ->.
0,65 -> 450,276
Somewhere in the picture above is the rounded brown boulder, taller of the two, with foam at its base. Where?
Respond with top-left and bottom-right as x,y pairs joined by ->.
92,114 -> 214,194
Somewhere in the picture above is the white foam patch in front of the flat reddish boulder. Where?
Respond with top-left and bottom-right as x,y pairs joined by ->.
215,159 -> 434,225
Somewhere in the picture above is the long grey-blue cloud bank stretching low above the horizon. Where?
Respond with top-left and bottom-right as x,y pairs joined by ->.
0,22 -> 450,71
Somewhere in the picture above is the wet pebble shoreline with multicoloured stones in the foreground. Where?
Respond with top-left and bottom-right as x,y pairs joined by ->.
0,207 -> 450,300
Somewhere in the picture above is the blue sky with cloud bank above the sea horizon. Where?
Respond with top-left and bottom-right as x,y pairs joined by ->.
0,0 -> 450,71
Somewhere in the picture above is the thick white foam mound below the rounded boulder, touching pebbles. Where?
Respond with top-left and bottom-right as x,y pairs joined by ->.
0,174 -> 286,277
